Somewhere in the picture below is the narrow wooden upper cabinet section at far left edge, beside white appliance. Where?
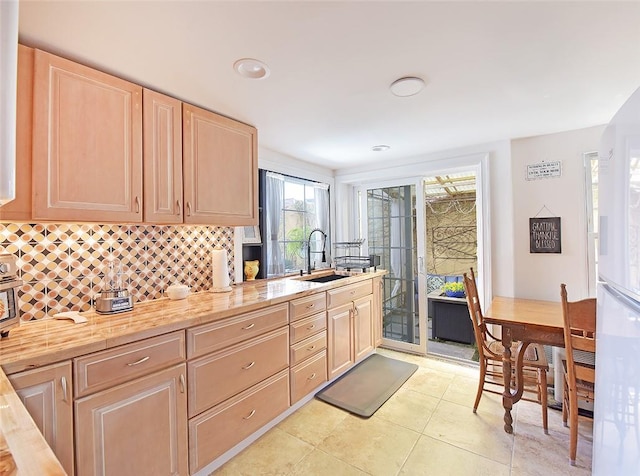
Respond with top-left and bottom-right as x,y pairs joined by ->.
0,45 -> 34,221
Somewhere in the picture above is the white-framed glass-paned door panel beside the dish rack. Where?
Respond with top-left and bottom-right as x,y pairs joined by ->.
359,178 -> 427,354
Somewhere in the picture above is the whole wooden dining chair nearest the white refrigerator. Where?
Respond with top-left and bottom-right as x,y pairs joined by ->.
560,284 -> 596,466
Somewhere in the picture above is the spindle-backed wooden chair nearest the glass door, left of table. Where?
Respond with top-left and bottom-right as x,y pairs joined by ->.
463,268 -> 549,433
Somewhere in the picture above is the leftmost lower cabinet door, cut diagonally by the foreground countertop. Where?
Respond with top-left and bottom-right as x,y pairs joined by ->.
9,362 -> 73,475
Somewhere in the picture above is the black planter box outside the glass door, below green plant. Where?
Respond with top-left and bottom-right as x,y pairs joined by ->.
429,296 -> 476,344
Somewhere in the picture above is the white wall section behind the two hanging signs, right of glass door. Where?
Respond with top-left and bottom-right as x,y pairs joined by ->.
510,126 -> 604,301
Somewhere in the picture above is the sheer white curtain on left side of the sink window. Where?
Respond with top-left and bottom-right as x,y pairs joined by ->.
265,172 -> 284,277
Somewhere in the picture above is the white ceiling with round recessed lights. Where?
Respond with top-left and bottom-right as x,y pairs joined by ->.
17,0 -> 640,169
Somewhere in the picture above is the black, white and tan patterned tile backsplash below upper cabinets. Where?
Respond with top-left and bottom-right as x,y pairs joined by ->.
0,223 -> 235,320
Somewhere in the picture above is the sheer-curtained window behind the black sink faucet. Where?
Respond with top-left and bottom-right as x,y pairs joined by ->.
265,172 -> 331,277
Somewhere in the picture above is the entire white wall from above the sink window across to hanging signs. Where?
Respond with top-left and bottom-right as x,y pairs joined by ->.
258,126 -> 604,301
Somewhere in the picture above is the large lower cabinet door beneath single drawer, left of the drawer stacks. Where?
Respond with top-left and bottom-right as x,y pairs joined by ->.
75,364 -> 188,476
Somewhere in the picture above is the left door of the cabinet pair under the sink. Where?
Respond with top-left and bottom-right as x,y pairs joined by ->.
327,303 -> 354,380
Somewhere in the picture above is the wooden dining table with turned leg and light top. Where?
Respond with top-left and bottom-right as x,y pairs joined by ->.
484,296 -> 564,433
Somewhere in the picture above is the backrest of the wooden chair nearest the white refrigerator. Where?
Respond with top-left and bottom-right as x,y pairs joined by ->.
560,284 -> 596,381
